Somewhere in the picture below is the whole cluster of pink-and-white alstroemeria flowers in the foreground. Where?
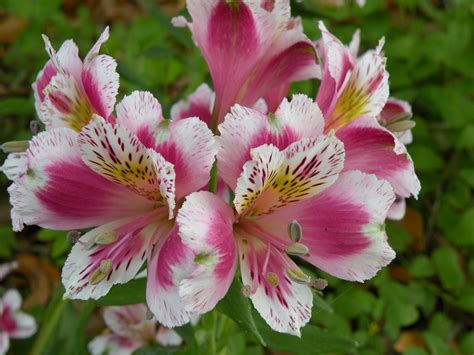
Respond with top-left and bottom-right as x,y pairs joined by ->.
2,0 -> 420,335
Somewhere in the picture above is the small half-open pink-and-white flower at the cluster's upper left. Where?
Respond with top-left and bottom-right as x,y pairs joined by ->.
32,27 -> 119,131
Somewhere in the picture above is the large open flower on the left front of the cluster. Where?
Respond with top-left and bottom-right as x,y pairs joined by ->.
9,91 -> 217,326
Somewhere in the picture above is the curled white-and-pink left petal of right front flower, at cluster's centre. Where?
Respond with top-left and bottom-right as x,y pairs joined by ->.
176,191 -> 237,313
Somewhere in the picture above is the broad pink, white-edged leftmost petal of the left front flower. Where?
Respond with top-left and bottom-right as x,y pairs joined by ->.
8,128 -> 154,230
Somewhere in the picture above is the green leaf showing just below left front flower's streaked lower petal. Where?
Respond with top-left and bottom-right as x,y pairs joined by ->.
95,278 -> 146,306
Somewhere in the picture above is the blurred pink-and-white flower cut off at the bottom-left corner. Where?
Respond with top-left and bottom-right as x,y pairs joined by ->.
0,289 -> 37,354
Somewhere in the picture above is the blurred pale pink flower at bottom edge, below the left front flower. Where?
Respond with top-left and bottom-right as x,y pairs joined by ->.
88,304 -> 182,355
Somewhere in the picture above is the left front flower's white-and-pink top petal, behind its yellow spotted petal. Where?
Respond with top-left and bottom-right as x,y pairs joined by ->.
117,91 -> 217,199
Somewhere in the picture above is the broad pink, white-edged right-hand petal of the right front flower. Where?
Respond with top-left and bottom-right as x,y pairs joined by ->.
258,171 -> 395,281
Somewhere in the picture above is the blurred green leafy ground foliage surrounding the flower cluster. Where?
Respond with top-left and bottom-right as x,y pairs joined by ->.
0,0 -> 474,355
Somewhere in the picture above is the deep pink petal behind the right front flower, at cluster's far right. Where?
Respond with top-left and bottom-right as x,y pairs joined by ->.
337,118 -> 420,197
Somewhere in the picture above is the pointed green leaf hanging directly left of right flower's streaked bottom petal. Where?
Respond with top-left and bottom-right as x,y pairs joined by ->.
216,278 -> 265,346
